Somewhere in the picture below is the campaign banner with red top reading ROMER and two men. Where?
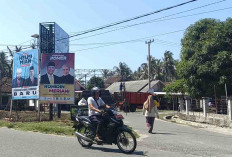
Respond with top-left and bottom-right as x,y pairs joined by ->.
40,53 -> 74,104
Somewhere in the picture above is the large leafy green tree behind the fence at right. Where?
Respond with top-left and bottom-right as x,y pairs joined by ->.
177,18 -> 232,98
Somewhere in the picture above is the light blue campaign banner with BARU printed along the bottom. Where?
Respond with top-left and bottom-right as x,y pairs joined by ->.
12,49 -> 39,100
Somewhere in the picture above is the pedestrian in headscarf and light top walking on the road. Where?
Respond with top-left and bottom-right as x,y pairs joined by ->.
143,89 -> 159,133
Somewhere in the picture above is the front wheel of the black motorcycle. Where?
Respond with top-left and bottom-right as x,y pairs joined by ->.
117,131 -> 137,154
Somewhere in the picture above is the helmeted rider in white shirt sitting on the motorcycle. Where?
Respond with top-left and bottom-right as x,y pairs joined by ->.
87,87 -> 110,141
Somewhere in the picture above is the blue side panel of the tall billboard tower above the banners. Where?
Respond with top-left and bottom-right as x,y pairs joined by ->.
54,23 -> 69,53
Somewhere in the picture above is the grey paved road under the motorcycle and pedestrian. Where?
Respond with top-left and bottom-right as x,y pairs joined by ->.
0,112 -> 232,157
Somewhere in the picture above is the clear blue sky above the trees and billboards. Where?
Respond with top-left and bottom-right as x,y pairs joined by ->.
0,0 -> 232,71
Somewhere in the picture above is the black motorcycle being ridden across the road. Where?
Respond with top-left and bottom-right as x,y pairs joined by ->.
74,108 -> 137,154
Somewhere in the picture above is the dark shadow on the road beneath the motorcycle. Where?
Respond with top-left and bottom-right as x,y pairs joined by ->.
89,146 -> 147,156
